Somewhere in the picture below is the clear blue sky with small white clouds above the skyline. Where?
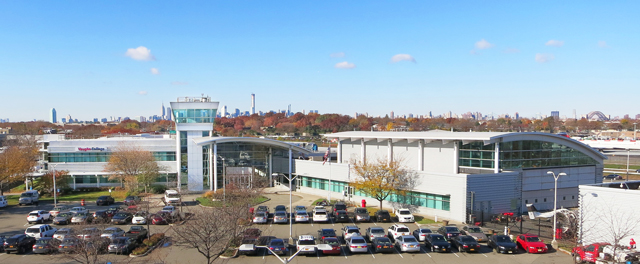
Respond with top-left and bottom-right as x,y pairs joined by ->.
0,1 -> 640,121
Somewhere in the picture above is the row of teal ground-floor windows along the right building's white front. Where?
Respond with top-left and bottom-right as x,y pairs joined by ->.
298,176 -> 451,211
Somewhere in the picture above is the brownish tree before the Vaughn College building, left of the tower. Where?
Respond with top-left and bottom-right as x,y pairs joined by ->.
104,142 -> 160,191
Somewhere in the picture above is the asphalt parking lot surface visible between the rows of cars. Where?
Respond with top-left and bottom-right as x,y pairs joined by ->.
0,194 -> 573,264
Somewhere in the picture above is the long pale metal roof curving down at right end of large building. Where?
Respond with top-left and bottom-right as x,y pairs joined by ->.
323,130 -> 607,160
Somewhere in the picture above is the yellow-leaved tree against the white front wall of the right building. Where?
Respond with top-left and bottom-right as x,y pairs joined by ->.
351,159 -> 418,209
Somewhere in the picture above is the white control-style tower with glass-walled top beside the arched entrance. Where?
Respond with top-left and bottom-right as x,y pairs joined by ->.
171,96 -> 219,191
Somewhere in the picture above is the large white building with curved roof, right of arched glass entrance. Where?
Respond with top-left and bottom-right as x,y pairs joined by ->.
296,131 -> 605,222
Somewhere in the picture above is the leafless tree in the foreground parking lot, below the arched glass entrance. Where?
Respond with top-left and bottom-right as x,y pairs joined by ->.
173,188 -> 260,264
